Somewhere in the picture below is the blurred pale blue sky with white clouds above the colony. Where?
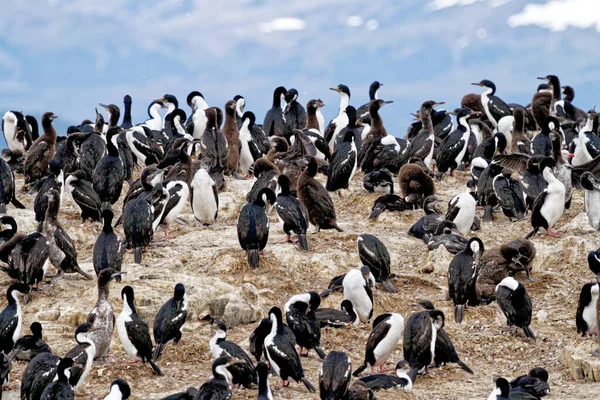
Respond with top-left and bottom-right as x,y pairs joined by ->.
0,0 -> 600,144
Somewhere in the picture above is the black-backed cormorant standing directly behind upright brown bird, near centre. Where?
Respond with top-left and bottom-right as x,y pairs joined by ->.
325,131 -> 358,197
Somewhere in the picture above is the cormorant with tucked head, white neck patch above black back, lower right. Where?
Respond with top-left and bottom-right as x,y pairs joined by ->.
496,276 -> 535,340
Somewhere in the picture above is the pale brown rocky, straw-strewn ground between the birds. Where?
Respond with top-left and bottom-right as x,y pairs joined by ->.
0,167 -> 600,399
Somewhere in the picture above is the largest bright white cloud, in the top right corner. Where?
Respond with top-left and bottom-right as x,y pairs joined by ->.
508,0 -> 600,32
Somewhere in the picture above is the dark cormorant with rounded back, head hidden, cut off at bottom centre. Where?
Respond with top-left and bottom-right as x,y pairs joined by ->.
319,351 -> 352,400
